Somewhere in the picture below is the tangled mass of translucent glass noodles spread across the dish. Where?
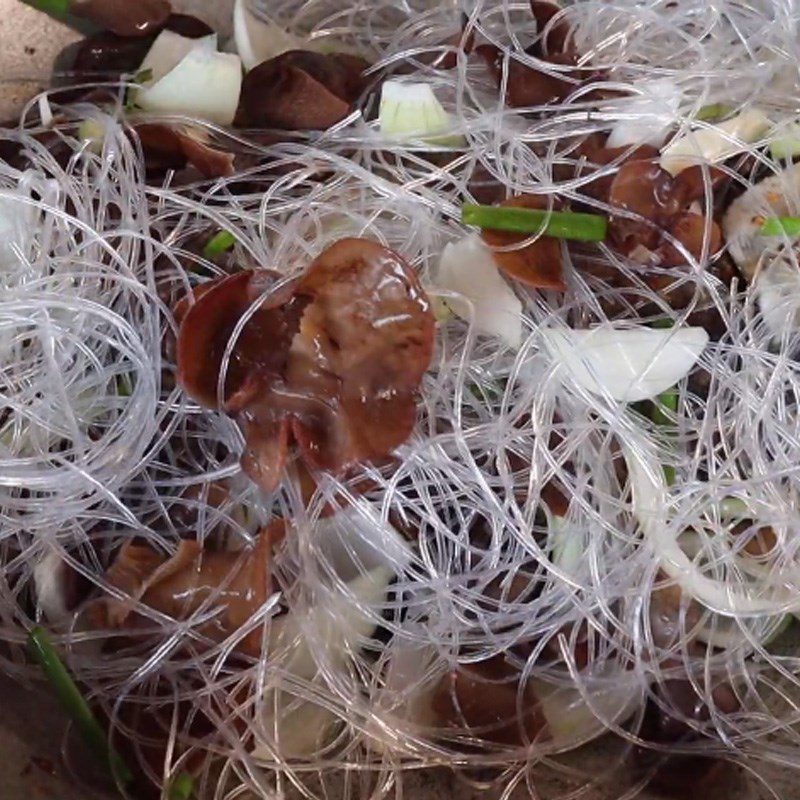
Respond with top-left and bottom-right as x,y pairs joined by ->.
0,0 -> 800,800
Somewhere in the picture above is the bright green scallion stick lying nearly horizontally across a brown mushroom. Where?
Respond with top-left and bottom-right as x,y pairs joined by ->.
461,203 -> 608,242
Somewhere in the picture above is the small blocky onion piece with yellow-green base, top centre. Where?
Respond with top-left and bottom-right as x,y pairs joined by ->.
378,80 -> 464,147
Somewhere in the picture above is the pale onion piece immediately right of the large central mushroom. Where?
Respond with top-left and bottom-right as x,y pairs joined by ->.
435,234 -> 522,350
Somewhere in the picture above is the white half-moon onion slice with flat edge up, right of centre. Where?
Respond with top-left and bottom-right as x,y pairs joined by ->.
541,324 -> 708,403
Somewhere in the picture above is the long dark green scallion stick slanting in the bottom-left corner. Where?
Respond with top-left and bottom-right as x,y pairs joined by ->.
28,627 -> 133,786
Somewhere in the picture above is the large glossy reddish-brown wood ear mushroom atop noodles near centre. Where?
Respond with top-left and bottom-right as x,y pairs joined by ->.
177,239 -> 434,490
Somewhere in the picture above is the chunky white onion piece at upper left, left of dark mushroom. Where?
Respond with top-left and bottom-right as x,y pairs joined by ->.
135,36 -> 242,125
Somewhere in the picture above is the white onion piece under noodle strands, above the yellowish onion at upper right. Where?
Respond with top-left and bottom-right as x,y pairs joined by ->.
601,78 -> 683,147
